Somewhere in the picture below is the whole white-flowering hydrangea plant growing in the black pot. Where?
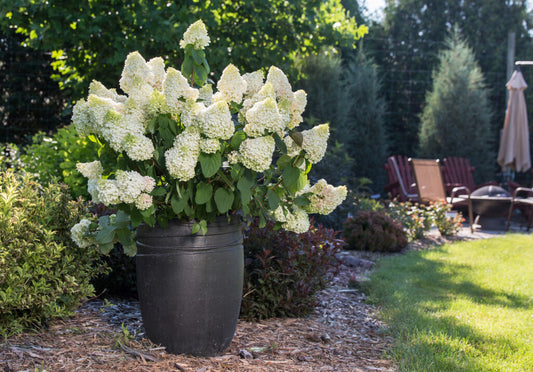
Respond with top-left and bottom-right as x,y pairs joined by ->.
72,21 -> 346,255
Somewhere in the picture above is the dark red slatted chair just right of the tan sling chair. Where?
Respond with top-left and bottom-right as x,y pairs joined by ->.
442,156 -> 497,195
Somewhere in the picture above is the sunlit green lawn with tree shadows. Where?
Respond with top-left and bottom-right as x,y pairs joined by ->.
367,235 -> 533,372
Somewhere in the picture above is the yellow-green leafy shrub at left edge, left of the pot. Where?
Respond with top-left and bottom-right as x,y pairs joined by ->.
0,170 -> 105,335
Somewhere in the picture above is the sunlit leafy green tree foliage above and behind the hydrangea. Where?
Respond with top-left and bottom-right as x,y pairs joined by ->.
0,0 -> 364,98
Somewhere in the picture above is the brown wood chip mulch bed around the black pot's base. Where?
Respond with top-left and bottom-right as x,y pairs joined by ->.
0,248 -> 396,372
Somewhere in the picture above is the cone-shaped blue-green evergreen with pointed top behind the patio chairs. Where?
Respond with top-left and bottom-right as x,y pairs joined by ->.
419,29 -> 496,182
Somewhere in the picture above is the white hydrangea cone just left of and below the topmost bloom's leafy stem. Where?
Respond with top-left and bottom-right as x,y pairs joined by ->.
163,67 -> 200,114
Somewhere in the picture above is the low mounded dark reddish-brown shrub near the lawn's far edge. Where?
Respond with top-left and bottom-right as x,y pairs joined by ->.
343,210 -> 407,252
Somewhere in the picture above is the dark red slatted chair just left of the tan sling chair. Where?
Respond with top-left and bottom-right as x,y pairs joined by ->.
383,155 -> 418,202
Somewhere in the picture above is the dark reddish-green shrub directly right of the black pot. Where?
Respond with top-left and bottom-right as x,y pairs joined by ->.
241,221 -> 344,319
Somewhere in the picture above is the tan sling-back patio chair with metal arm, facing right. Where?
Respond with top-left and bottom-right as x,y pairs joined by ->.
408,158 -> 474,233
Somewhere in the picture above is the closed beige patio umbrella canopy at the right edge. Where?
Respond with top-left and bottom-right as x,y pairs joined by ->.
498,70 -> 531,172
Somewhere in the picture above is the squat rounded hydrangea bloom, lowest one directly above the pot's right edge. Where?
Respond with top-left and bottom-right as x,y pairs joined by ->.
239,136 -> 276,172
